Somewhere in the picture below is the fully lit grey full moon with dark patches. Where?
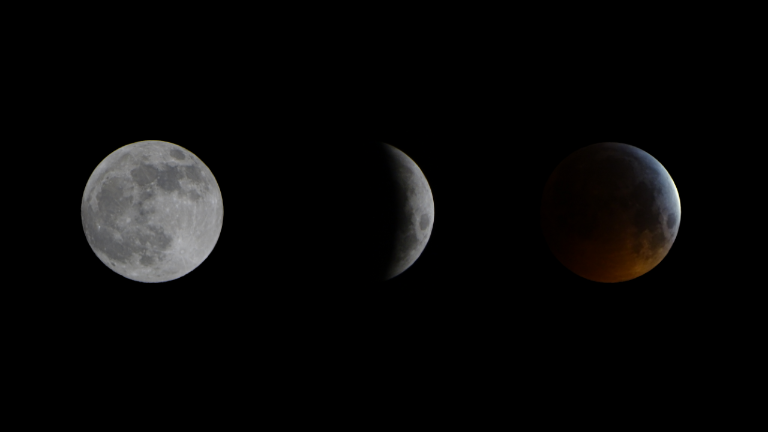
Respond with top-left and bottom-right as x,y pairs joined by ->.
81,141 -> 224,282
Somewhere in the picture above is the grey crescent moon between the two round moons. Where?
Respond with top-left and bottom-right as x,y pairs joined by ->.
383,144 -> 435,280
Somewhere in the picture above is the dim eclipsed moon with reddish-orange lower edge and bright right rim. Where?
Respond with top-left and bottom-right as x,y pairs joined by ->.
541,143 -> 680,282
